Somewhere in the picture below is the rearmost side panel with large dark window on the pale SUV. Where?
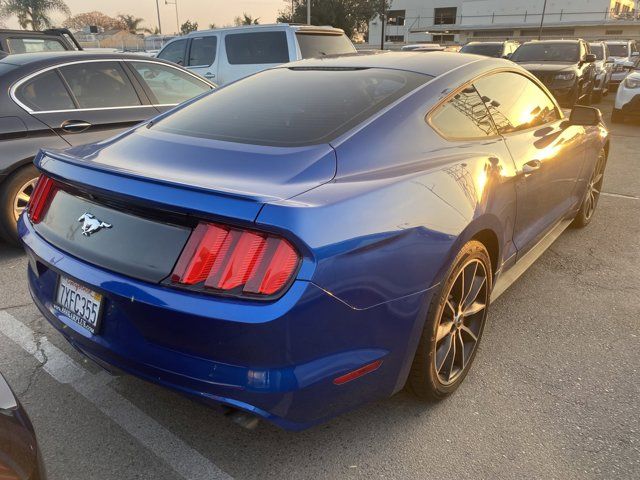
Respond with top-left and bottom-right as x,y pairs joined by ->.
216,30 -> 290,85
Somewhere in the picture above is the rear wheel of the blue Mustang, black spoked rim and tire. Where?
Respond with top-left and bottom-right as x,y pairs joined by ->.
408,240 -> 493,401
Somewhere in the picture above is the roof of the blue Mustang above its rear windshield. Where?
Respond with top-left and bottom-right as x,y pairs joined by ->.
282,50 -> 500,77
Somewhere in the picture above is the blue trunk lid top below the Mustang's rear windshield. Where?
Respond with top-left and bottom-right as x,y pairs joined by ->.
64,127 -> 336,203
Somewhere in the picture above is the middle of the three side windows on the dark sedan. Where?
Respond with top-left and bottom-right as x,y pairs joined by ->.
60,62 -> 140,108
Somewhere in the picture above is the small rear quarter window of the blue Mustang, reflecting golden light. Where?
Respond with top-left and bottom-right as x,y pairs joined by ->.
429,86 -> 497,139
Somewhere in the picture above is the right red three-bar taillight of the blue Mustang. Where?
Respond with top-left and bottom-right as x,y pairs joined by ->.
171,223 -> 300,297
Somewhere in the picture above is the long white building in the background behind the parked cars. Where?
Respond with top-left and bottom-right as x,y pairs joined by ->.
369,0 -> 640,45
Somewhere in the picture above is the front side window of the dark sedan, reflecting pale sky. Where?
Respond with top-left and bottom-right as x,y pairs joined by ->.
131,62 -> 211,105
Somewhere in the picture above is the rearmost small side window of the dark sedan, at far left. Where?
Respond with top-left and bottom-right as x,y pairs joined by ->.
16,70 -> 76,112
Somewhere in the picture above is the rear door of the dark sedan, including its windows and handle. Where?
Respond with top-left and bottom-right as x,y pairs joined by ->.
16,60 -> 157,145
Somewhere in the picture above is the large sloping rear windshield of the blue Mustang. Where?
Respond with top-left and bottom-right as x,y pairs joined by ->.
152,68 -> 432,146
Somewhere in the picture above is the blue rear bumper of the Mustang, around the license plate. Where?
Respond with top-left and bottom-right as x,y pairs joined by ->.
19,218 -> 430,430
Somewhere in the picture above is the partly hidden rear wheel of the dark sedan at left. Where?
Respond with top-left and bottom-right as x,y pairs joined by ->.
0,165 -> 38,245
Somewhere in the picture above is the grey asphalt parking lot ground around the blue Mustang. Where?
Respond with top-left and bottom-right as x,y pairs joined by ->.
0,95 -> 640,480
